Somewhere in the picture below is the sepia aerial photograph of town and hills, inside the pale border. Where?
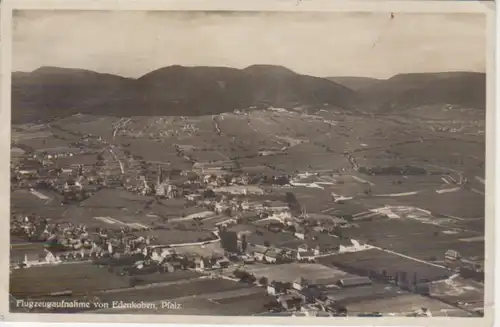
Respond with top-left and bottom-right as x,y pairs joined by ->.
2,2 -> 493,324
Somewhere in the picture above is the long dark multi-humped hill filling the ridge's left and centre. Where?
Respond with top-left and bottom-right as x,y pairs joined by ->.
12,65 -> 358,122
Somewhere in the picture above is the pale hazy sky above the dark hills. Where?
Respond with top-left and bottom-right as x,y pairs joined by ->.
12,10 -> 487,78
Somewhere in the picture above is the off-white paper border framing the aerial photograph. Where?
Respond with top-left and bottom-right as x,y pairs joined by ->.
0,0 -> 497,327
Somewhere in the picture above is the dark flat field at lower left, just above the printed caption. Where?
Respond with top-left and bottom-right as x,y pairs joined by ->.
10,263 -> 129,298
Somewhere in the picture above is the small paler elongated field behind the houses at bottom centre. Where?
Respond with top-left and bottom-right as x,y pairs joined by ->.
236,263 -> 349,284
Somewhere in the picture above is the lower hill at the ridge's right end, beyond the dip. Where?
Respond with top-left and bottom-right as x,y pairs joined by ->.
357,72 -> 486,113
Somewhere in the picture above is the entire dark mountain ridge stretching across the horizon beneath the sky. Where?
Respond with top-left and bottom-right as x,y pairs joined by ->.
12,64 -> 486,123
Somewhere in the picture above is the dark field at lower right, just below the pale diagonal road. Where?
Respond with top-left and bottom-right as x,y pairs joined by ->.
318,249 -> 451,281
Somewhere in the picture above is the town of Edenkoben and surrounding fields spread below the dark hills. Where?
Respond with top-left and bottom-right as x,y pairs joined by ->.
10,108 -> 484,317
